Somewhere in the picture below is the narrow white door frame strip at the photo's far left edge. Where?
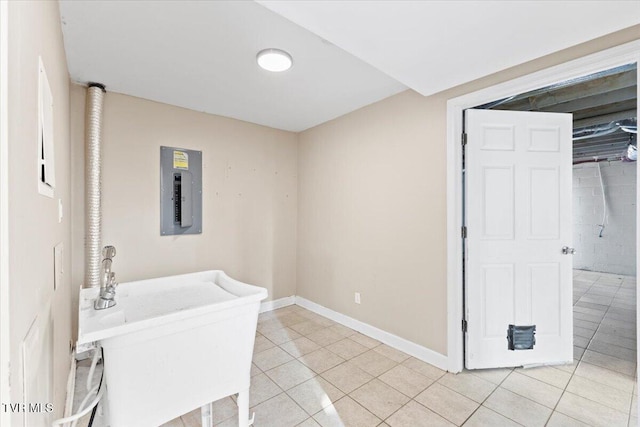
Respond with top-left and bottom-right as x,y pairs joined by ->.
0,0 -> 11,426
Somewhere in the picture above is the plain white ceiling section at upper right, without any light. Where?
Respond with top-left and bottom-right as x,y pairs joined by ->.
257,0 -> 640,95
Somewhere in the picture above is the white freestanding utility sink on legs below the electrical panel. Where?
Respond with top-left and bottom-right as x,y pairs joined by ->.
78,270 -> 267,427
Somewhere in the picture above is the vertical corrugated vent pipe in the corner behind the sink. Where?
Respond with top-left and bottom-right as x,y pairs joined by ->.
84,83 -> 106,287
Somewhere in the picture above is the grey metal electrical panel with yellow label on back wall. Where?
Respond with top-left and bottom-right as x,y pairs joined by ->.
160,147 -> 202,236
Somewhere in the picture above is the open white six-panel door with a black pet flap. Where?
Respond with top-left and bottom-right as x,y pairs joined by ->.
465,110 -> 573,369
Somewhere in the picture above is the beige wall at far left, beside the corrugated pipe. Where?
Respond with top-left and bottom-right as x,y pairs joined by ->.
4,2 -> 71,426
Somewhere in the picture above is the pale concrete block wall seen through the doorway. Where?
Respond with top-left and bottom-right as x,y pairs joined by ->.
573,161 -> 637,275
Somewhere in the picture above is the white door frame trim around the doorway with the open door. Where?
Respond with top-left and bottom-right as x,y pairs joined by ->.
447,40 -> 640,372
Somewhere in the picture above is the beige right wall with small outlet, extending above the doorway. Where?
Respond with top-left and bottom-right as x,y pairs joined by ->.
297,26 -> 640,354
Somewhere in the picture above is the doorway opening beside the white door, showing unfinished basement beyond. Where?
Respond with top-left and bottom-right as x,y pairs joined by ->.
476,63 -> 638,376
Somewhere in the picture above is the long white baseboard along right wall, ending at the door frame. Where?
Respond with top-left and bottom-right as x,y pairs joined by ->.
295,296 -> 449,370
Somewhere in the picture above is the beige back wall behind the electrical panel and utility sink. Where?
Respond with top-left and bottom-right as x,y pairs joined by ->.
71,85 -> 297,332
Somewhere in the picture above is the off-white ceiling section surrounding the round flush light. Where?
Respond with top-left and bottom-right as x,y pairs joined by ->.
60,0 -> 406,131
